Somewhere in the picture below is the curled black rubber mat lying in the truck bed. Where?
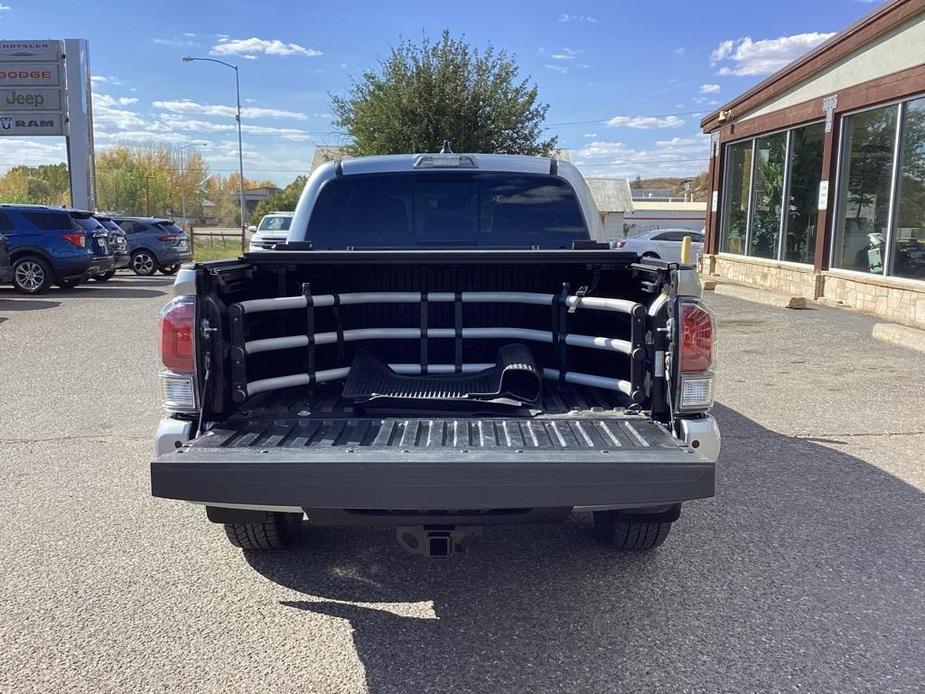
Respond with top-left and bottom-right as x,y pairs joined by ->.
342,344 -> 542,407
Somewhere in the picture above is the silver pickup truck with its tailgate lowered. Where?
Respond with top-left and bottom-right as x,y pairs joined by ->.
151,154 -> 720,556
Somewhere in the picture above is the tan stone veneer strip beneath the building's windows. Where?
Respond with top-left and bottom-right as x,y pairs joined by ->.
700,255 -> 925,329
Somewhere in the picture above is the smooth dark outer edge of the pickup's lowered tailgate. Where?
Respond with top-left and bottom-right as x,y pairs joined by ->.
151,448 -> 715,510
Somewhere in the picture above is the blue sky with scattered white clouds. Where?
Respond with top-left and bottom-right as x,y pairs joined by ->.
0,0 -> 888,183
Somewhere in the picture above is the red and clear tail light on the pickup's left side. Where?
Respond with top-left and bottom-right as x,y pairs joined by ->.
161,296 -> 196,412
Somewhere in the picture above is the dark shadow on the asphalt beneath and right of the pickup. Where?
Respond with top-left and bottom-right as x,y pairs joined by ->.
246,406 -> 925,693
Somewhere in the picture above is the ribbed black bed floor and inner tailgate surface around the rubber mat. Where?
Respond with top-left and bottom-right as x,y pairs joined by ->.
192,381 -> 677,452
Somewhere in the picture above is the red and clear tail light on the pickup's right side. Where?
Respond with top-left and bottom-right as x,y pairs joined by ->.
678,301 -> 716,412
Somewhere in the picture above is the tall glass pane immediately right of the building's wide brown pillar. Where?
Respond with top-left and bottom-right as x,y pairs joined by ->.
832,105 -> 898,274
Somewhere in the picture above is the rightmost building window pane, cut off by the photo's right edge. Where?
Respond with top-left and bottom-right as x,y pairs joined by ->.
890,98 -> 925,280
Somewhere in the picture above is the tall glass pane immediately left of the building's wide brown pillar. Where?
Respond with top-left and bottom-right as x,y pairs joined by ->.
783,123 -> 825,263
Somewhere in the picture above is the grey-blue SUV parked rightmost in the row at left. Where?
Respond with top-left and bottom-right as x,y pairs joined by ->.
112,215 -> 193,276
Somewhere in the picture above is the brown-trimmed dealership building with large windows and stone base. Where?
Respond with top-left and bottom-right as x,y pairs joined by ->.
701,0 -> 925,328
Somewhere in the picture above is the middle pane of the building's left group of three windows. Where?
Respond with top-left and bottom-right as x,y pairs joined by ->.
748,133 -> 787,258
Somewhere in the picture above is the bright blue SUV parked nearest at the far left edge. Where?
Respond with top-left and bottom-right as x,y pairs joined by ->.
0,204 -> 112,294
